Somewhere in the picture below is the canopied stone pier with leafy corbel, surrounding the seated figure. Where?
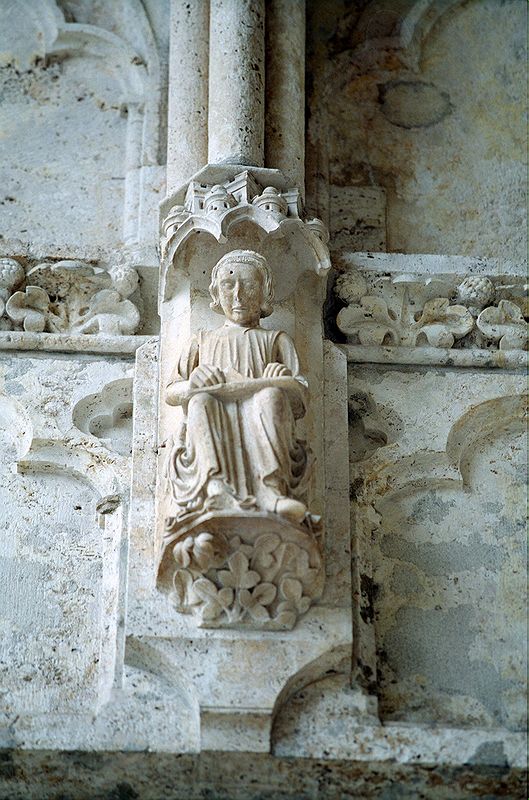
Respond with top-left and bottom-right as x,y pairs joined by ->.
127,166 -> 352,751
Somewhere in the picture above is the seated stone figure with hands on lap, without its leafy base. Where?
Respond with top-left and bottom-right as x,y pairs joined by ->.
166,250 -> 308,524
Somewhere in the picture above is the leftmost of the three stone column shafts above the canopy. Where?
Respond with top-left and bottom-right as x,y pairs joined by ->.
167,0 -> 209,195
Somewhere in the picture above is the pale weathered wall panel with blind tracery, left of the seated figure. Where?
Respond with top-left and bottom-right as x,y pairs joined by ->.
0,354 -> 136,716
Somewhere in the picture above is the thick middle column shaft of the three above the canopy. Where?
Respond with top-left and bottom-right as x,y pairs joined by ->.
208,0 -> 265,167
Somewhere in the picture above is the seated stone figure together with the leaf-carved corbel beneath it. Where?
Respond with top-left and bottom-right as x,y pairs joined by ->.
160,250 -> 322,628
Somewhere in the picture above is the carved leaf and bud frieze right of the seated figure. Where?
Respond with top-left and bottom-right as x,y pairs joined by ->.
334,254 -> 528,362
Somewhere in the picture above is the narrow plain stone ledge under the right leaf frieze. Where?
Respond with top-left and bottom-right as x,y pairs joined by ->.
337,344 -> 529,371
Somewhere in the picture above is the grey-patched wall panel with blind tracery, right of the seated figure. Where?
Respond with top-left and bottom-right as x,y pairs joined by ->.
349,365 -> 527,740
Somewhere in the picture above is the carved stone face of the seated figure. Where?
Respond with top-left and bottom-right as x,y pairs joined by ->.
217,262 -> 264,326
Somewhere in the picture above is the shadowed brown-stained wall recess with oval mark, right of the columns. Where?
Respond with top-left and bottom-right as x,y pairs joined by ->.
308,0 -> 527,259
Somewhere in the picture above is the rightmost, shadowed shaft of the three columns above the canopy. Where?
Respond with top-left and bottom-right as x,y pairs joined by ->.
265,0 -> 305,197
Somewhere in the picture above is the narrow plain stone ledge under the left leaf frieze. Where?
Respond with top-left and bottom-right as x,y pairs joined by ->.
0,331 -> 158,355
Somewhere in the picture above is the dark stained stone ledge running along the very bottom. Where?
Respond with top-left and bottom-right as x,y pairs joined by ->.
0,750 -> 527,800
